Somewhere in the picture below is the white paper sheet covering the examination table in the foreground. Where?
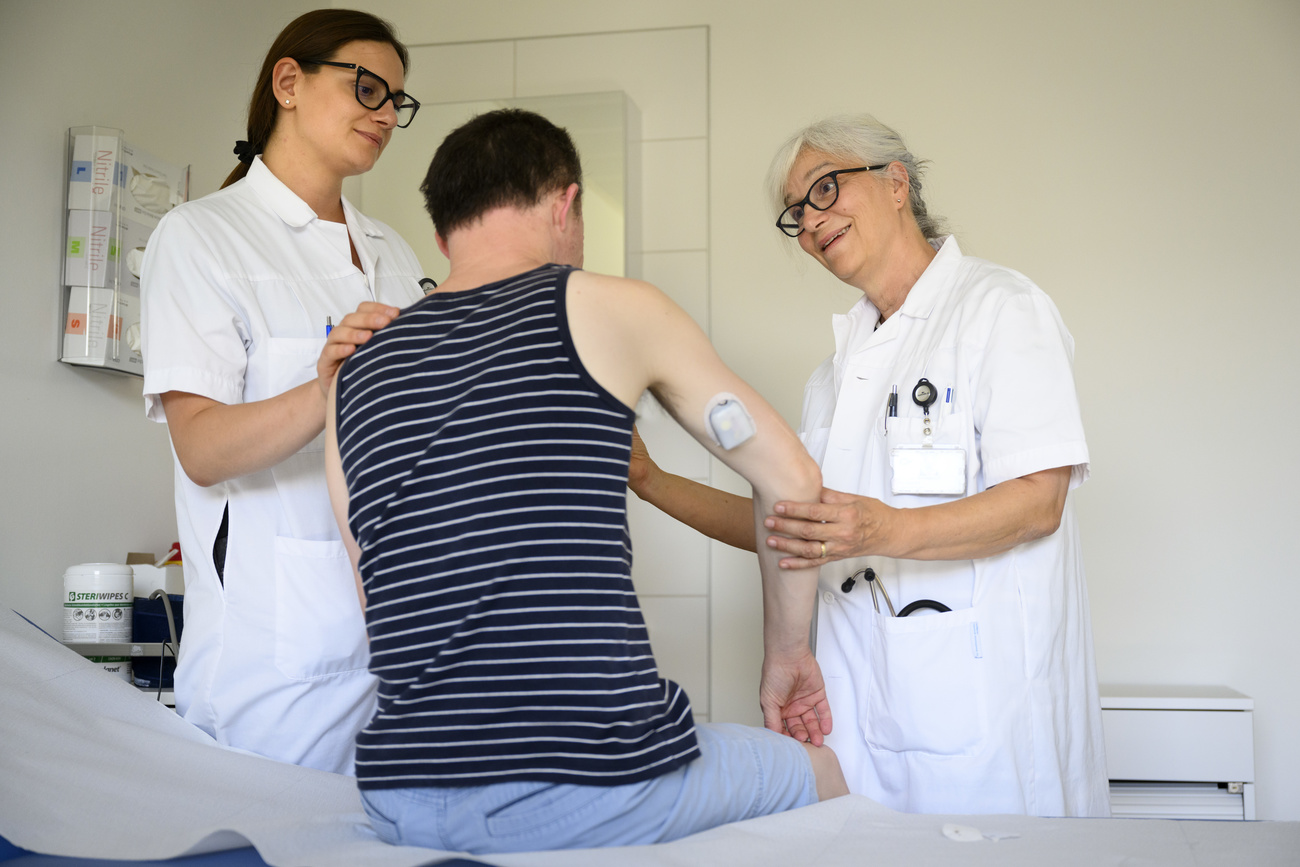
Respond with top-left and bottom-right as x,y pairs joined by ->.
0,610 -> 1300,867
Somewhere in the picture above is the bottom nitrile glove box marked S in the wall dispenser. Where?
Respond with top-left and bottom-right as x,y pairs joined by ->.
60,282 -> 144,376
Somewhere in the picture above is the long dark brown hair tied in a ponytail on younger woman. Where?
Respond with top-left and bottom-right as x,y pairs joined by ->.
221,9 -> 410,188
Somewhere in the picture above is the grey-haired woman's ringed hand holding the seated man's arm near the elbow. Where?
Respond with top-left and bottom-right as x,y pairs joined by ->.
763,487 -> 898,569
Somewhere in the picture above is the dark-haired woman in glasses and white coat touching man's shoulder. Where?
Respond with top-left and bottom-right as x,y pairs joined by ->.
142,9 -> 423,773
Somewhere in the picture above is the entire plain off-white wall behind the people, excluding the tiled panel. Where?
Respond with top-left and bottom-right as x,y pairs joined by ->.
0,0 -> 1300,819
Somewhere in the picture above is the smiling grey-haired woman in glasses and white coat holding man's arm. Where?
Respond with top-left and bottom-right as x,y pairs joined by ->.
629,116 -> 1109,816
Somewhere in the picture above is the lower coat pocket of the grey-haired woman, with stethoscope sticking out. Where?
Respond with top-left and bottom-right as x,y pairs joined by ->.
861,608 -> 988,755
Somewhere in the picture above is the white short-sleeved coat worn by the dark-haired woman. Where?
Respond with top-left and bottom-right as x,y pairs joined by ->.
142,157 -> 423,773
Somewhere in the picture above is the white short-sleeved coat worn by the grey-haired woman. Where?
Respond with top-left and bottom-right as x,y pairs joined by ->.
801,238 -> 1110,816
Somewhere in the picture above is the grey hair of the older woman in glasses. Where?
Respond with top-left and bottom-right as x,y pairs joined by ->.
767,114 -> 948,242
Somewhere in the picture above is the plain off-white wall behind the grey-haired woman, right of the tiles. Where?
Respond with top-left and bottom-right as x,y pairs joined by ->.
367,0 -> 1300,819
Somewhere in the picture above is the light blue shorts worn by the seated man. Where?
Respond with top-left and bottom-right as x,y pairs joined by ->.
361,723 -> 816,854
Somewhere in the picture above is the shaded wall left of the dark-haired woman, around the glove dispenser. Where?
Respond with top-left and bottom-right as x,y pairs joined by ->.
0,0 -> 312,636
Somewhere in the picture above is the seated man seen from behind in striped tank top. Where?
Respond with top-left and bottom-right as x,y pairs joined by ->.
326,110 -> 848,853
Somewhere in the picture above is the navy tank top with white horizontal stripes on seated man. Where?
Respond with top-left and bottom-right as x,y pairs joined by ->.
338,265 -> 698,788
